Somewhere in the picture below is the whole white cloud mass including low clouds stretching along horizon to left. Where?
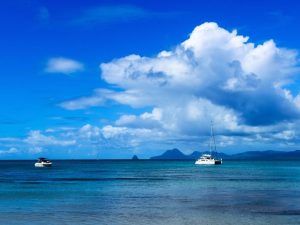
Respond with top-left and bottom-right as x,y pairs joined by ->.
4,23 -> 300,156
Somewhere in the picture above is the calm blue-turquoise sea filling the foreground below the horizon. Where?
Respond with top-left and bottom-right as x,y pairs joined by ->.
0,161 -> 300,225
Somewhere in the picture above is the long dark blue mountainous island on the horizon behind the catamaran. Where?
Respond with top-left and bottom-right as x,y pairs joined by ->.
150,148 -> 300,160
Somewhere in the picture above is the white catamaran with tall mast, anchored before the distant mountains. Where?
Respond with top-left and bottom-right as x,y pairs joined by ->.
195,122 -> 222,165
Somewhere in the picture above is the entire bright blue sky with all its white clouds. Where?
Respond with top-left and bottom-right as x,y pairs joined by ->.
0,0 -> 300,159
